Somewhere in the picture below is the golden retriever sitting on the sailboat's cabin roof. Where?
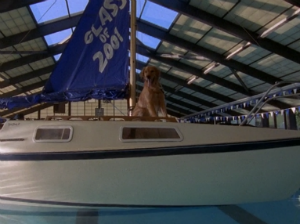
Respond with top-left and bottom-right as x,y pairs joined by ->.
132,66 -> 167,117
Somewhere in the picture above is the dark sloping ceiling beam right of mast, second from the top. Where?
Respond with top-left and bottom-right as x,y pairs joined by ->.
137,19 -> 281,85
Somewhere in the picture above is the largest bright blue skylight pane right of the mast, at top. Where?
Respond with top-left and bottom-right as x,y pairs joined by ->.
141,1 -> 178,29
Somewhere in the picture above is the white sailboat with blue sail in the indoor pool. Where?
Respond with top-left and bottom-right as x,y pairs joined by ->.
0,0 -> 300,208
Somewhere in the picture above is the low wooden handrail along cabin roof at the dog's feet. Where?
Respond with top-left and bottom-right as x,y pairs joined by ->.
45,115 -> 177,122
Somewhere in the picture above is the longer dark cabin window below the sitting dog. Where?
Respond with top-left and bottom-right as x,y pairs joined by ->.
121,127 -> 182,141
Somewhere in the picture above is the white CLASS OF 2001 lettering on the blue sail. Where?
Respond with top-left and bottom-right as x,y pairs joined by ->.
84,0 -> 127,73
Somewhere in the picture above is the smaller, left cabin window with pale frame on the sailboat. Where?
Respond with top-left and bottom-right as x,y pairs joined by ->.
34,126 -> 73,142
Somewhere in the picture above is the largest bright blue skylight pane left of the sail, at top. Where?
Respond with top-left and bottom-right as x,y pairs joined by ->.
30,0 -> 68,23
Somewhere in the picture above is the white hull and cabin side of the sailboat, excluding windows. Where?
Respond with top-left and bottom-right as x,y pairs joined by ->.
0,121 -> 300,207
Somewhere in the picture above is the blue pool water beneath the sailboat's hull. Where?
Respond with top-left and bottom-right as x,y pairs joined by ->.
0,191 -> 300,224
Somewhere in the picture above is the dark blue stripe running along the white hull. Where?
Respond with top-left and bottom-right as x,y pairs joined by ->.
0,138 -> 300,161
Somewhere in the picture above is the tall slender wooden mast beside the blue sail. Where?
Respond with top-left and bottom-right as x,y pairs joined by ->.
129,0 -> 136,116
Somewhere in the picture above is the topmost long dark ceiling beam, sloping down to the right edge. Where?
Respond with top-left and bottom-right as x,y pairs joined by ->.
150,0 -> 300,64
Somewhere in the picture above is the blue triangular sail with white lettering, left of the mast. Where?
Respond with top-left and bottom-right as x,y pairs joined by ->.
0,0 -> 130,109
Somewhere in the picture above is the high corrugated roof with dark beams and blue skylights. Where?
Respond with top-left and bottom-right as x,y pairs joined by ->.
0,0 -> 300,119
